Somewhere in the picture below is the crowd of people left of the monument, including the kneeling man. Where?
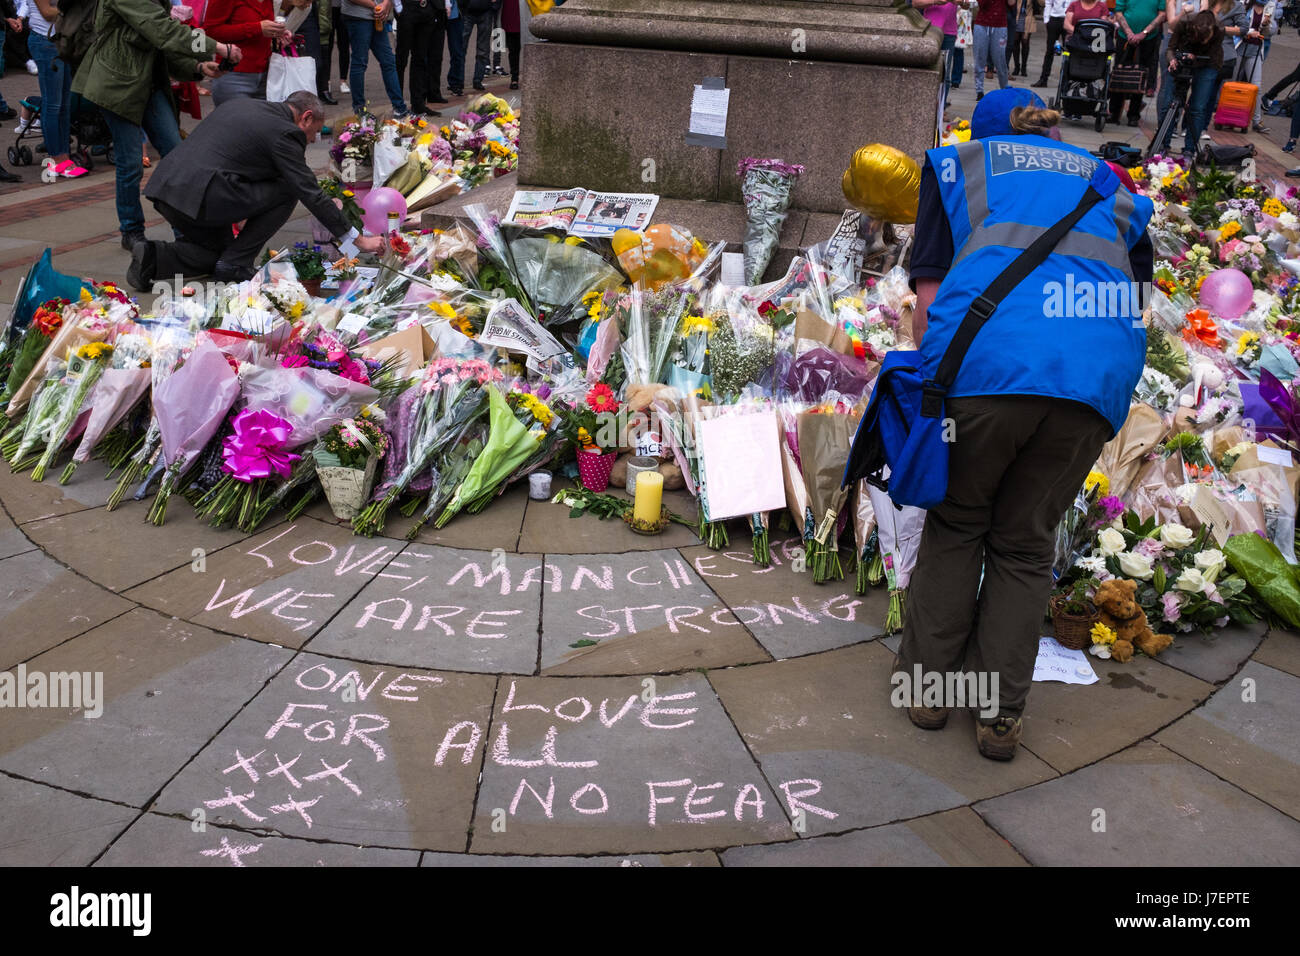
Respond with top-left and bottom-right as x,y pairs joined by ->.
0,0 -> 523,267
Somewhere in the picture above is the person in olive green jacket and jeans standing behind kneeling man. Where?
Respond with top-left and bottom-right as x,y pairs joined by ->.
73,0 -> 239,250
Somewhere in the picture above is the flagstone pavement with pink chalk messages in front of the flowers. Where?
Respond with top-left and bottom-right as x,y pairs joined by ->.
0,54 -> 1300,866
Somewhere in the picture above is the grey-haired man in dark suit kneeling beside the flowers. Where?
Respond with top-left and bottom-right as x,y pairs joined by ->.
126,91 -> 384,291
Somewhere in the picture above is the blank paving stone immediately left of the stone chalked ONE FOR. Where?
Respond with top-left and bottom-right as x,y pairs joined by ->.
0,609 -> 290,806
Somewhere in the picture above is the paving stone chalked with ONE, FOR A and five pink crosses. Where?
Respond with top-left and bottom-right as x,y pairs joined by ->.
153,653 -> 497,852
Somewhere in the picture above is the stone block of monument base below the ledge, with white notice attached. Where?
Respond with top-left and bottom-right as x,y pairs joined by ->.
519,35 -> 940,214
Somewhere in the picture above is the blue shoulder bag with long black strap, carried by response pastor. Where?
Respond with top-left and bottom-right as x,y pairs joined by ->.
841,174 -> 1118,509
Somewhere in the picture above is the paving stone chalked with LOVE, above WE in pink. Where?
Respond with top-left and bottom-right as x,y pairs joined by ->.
126,518 -> 405,648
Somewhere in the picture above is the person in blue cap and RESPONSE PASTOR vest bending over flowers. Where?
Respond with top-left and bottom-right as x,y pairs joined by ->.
894,88 -> 1152,760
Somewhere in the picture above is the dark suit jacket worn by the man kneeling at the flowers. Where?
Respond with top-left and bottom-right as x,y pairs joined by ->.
144,96 -> 351,237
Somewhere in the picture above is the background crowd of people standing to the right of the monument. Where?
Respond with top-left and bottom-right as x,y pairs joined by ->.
913,0 -> 1300,153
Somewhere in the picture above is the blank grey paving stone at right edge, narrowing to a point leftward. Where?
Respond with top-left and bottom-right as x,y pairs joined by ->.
1156,661 -> 1300,819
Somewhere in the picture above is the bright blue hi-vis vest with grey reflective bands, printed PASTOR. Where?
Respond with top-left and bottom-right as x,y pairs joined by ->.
920,135 -> 1153,432
